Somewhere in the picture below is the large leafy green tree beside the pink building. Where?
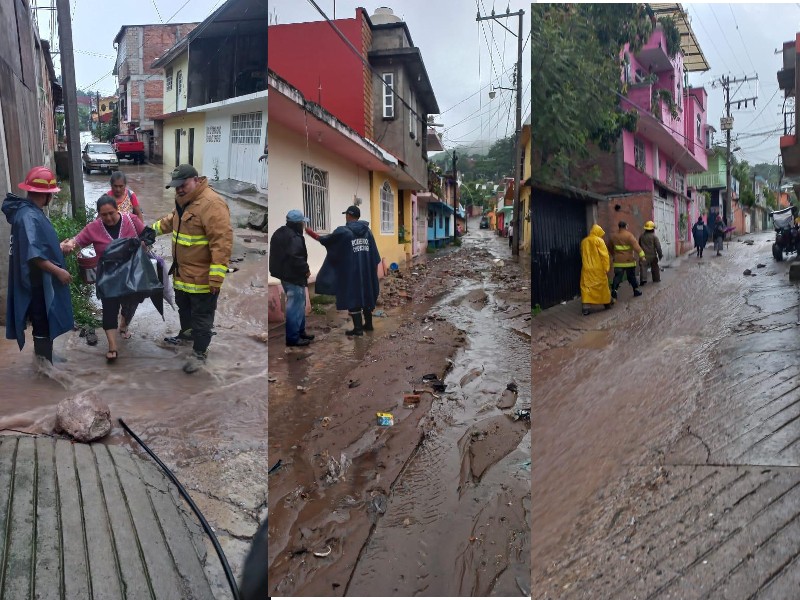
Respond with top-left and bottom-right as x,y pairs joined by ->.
531,4 -> 653,185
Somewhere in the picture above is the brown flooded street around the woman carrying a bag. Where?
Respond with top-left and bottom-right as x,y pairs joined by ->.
0,162 -> 267,598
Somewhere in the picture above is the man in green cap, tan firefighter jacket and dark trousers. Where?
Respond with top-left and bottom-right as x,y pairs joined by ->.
152,165 -> 233,373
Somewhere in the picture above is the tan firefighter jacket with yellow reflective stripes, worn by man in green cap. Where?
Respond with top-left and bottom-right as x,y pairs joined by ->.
151,177 -> 233,294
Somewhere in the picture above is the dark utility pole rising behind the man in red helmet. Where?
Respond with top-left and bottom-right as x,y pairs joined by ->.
56,0 -> 86,217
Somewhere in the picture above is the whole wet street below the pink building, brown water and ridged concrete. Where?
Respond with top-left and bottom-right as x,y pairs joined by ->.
532,233 -> 800,598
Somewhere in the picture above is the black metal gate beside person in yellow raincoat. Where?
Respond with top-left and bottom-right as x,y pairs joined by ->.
531,190 -> 588,308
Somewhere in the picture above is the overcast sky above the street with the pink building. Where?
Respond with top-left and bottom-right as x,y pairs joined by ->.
684,3 -> 800,170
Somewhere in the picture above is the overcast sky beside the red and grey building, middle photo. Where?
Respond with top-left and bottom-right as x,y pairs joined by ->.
269,0 -> 531,148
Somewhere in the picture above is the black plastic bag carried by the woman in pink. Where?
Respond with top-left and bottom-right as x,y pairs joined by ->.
96,238 -> 164,317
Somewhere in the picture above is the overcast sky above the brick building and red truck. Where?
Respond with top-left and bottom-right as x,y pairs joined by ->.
34,0 -> 224,94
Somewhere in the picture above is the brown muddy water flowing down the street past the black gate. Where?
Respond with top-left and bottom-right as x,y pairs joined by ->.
532,234 -> 772,584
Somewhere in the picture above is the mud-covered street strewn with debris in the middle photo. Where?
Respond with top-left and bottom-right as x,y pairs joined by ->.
269,223 -> 530,596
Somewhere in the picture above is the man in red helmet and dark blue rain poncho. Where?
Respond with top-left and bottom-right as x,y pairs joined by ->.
2,167 -> 74,363
